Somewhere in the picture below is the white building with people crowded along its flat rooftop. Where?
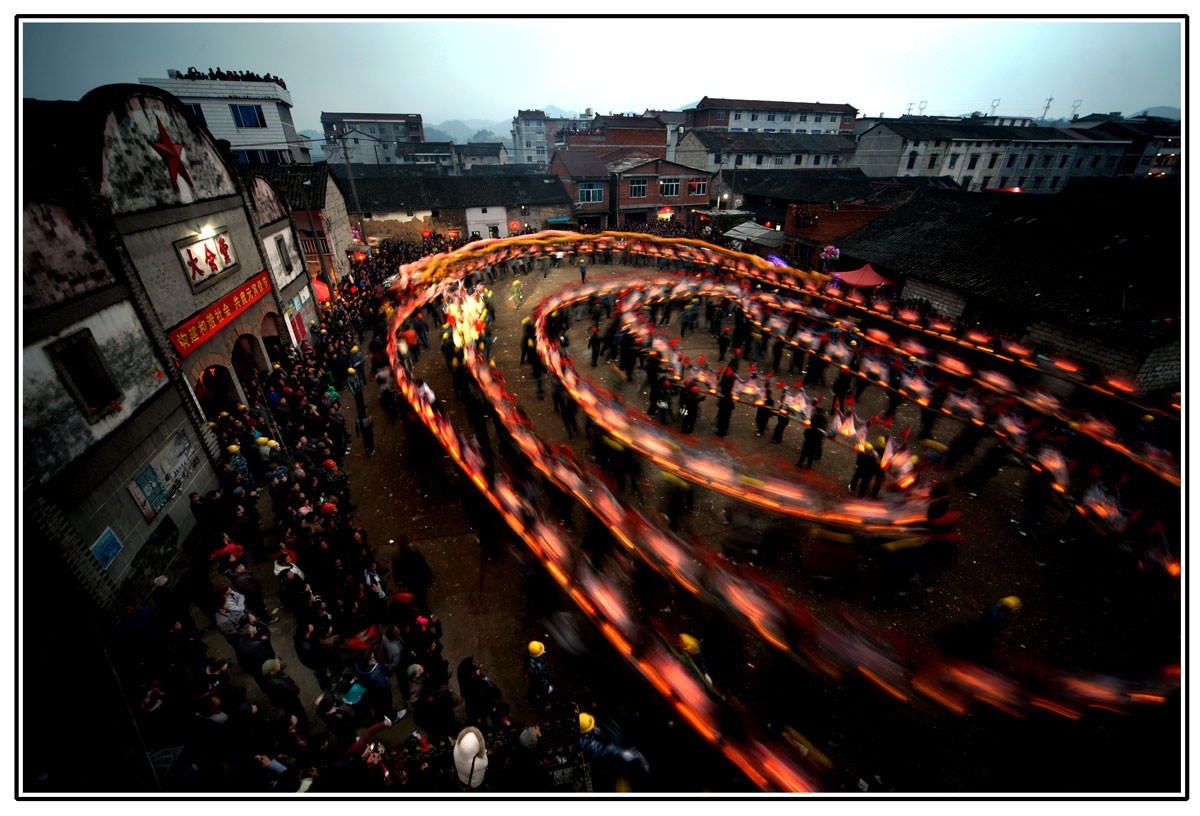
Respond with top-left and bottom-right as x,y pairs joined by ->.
138,71 -> 312,164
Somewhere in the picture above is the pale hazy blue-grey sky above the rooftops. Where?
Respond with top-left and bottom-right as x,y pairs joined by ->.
19,17 -> 1182,136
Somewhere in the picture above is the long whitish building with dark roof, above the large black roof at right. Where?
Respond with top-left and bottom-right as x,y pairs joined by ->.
845,120 -> 1129,193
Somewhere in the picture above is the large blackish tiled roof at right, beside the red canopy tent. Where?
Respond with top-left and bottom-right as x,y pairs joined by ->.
840,179 -> 1181,336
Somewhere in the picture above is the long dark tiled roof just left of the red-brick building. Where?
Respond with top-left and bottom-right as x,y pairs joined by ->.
328,174 -> 571,212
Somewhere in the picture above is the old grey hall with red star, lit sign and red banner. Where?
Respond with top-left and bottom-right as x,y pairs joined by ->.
22,84 -> 316,608
